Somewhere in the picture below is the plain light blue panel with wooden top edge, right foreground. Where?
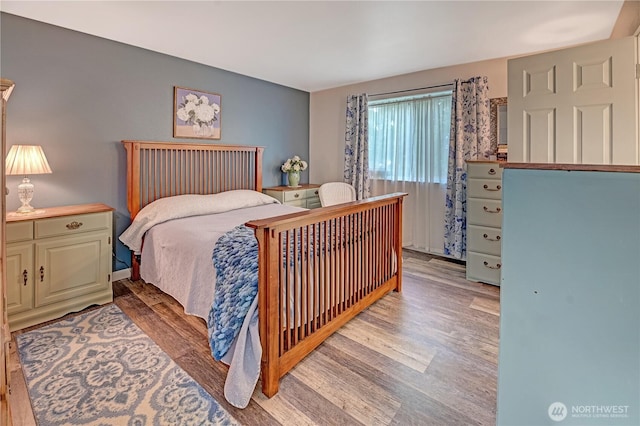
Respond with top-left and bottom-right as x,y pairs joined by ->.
497,163 -> 640,426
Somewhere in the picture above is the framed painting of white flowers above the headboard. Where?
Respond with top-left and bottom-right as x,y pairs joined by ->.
173,86 -> 222,139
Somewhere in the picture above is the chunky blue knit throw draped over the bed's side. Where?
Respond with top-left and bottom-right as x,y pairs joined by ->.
207,225 -> 258,360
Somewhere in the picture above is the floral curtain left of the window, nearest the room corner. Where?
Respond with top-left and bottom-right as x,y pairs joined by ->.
344,93 -> 370,200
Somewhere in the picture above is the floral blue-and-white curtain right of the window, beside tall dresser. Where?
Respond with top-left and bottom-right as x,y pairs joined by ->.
444,77 -> 495,259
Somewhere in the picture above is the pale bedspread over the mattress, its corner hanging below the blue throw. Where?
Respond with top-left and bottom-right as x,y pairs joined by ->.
132,204 -> 305,408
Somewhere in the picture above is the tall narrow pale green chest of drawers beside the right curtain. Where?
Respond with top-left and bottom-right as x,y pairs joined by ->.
467,161 -> 502,285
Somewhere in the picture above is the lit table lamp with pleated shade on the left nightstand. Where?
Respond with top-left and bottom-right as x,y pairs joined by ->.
5,145 -> 51,213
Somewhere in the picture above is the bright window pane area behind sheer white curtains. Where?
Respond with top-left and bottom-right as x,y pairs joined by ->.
369,91 -> 452,184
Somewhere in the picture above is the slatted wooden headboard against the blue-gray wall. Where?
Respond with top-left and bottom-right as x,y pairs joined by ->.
122,141 -> 264,219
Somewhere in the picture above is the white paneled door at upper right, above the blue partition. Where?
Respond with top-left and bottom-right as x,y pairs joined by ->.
508,37 -> 640,164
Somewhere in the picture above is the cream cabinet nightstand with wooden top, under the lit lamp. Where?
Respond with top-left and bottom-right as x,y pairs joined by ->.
6,203 -> 113,331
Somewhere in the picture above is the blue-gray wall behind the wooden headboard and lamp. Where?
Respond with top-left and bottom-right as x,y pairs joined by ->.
0,13 -> 309,270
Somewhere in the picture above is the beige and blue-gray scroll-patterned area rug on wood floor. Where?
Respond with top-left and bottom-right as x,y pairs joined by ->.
17,304 -> 238,426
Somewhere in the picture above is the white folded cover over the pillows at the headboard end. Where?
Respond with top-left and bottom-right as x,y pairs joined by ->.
119,189 -> 280,254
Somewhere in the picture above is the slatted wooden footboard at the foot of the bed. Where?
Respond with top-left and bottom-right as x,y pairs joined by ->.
247,193 -> 406,397
